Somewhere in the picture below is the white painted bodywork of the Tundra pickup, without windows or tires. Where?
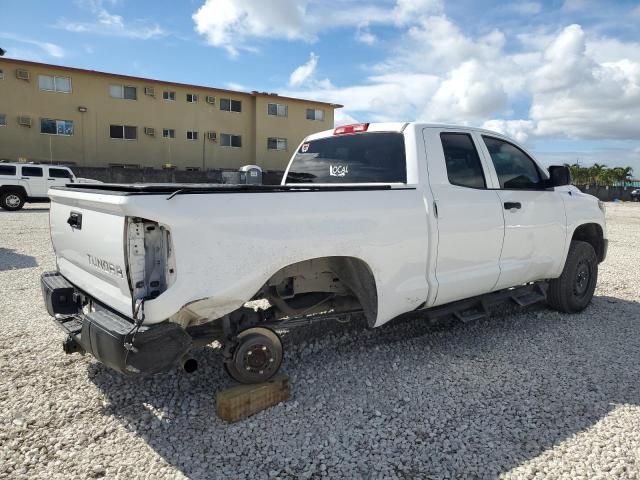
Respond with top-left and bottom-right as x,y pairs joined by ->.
49,123 -> 605,332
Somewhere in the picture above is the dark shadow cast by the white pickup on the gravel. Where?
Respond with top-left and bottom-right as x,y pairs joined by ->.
88,297 -> 640,478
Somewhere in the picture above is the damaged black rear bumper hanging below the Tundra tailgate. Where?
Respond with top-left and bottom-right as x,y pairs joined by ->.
40,272 -> 192,375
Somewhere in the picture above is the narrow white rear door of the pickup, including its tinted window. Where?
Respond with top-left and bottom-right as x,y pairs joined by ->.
423,128 -> 504,305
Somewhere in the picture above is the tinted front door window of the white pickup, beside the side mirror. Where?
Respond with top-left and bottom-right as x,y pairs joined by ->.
482,135 -> 544,190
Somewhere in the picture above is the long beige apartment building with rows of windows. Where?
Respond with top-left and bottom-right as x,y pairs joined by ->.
0,58 -> 341,170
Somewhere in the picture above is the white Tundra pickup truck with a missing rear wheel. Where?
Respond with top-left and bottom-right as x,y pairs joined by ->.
42,123 -> 607,383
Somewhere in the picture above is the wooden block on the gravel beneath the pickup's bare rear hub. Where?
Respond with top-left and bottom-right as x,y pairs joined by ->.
216,373 -> 289,422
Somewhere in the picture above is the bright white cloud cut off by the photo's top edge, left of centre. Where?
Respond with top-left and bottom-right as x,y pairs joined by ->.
192,0 -> 442,55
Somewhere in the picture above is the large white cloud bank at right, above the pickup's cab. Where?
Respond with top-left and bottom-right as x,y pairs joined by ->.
288,15 -> 640,141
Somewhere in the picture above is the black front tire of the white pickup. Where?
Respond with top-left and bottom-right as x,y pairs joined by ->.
547,240 -> 598,313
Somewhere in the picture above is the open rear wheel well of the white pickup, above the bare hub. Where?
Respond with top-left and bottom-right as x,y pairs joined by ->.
255,257 -> 378,325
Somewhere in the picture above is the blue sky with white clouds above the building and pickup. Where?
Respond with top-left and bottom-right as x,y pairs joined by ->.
0,0 -> 640,171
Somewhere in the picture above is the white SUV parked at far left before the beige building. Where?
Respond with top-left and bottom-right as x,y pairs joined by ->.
0,163 -> 76,210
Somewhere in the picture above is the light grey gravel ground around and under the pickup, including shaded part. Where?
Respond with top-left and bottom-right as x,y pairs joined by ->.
0,204 -> 640,479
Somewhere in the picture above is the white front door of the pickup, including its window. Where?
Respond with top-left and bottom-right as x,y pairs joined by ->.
482,135 -> 567,289
